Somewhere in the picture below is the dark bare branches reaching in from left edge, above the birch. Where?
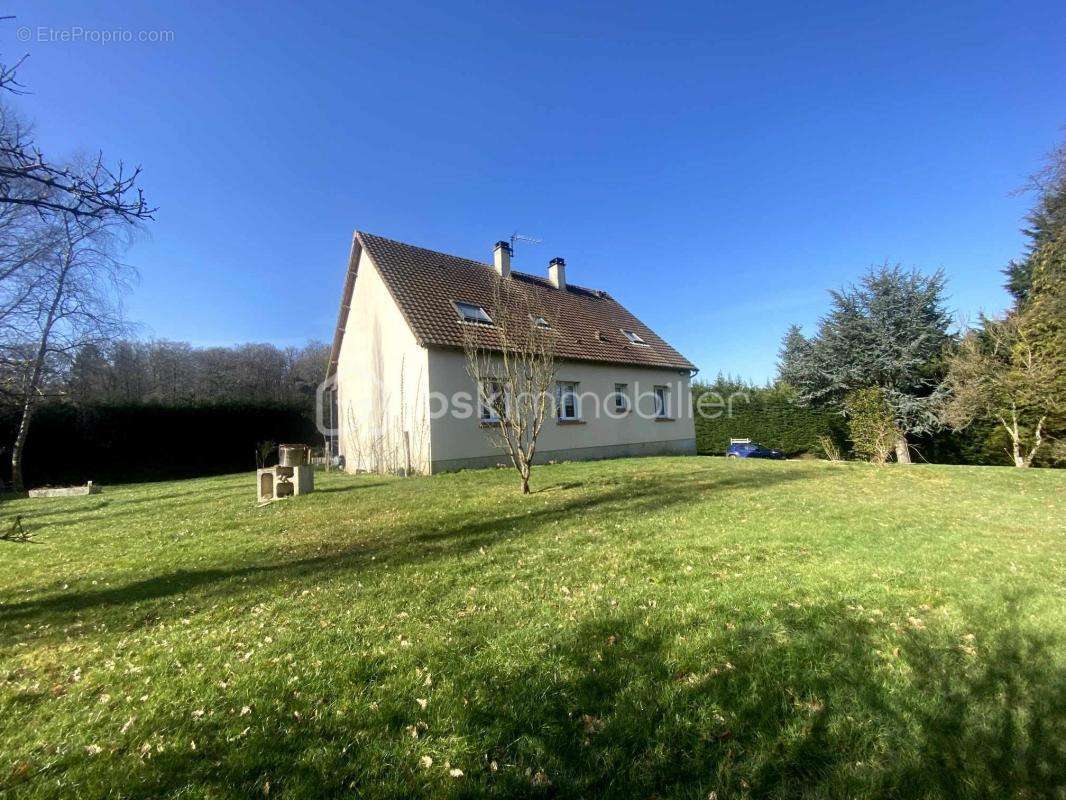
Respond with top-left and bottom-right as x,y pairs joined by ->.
0,60 -> 156,222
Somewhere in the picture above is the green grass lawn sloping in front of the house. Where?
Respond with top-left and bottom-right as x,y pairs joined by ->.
0,458 -> 1066,800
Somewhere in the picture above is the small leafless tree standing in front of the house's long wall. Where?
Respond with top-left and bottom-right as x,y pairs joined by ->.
463,277 -> 556,494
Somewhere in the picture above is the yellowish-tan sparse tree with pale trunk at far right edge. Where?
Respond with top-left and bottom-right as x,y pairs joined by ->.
943,314 -> 1066,467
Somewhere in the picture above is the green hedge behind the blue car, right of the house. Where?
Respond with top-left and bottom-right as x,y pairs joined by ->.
693,388 -> 847,457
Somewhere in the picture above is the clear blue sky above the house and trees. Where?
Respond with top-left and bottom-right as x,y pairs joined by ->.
0,1 -> 1066,380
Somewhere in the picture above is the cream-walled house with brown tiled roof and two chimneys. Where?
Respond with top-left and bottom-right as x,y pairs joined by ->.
326,231 -> 696,473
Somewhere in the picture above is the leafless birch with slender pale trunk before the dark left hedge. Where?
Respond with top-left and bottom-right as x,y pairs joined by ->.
0,218 -> 135,492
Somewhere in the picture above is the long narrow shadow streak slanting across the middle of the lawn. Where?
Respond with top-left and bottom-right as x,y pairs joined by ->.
0,471 -> 803,645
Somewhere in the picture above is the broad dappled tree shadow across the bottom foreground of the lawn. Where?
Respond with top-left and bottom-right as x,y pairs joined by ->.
18,606 -> 1066,800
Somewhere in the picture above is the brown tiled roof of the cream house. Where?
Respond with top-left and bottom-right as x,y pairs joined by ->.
329,231 -> 695,372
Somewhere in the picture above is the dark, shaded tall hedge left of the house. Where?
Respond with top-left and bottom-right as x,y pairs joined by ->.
0,403 -> 321,486
